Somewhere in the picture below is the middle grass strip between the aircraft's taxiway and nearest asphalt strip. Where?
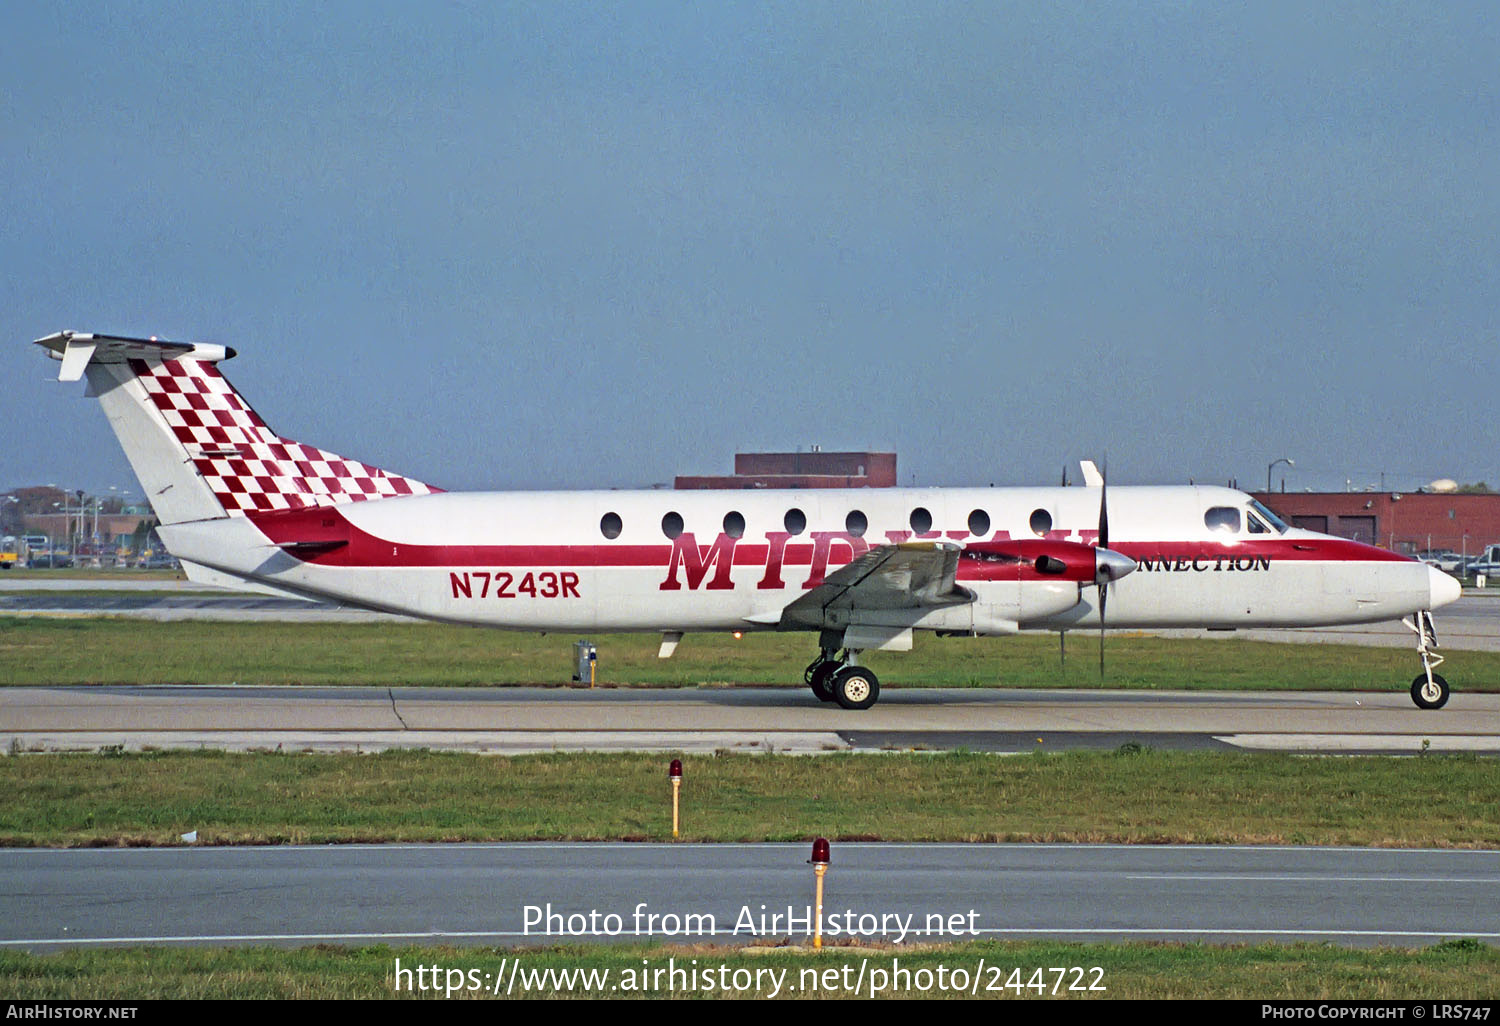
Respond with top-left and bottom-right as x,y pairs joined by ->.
0,750 -> 1500,848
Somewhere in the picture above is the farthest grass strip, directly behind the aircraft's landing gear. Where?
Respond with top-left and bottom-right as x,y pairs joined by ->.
0,617 -> 1500,692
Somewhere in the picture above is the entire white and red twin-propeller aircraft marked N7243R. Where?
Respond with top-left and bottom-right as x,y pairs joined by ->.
38,332 -> 1460,710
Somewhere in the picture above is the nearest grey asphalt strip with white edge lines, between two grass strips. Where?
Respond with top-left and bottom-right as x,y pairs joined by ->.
0,843 -> 1500,951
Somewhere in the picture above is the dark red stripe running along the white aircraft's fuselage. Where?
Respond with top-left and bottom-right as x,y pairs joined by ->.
246,506 -> 1410,581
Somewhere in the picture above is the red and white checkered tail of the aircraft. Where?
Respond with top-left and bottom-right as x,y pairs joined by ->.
38,332 -> 440,524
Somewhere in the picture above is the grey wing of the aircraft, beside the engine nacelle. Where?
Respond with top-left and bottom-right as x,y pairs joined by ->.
780,542 -> 974,627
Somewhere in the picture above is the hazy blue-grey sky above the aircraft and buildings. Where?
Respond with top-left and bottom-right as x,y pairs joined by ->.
0,0 -> 1500,492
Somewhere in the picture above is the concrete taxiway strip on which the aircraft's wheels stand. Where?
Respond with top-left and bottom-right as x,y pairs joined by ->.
0,686 -> 1500,755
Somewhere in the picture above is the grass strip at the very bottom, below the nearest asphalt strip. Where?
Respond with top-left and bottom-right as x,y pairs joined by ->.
0,941 -> 1500,1001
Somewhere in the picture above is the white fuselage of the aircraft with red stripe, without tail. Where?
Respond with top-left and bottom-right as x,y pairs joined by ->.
162,486 -> 1457,635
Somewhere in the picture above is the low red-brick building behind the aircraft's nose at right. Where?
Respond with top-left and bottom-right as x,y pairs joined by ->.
1254,492 -> 1500,555
